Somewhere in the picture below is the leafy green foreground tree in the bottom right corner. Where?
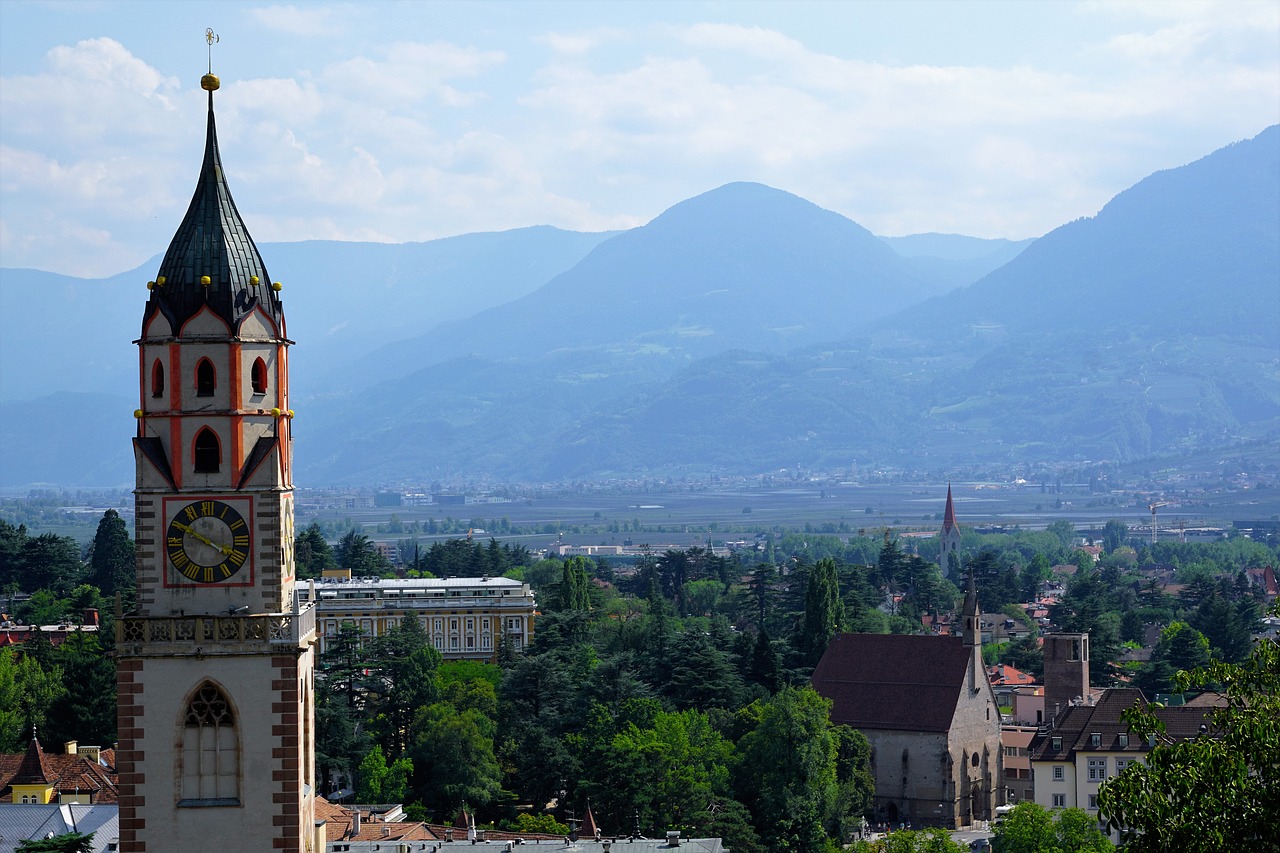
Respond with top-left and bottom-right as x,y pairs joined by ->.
1098,607 -> 1280,853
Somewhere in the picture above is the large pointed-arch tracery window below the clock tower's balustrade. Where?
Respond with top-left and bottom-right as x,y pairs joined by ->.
179,681 -> 239,806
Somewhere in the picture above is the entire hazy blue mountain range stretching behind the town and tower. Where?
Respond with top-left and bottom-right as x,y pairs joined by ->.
0,127 -> 1280,487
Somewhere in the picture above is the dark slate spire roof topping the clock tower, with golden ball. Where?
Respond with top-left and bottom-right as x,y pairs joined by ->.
147,74 -> 283,336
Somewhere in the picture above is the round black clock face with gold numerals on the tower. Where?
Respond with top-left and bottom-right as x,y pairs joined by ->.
165,498 -> 252,584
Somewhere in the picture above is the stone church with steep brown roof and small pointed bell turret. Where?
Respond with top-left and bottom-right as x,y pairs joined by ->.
813,576 -> 1004,829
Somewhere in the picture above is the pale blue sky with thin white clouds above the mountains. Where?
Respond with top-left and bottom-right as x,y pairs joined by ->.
0,0 -> 1280,277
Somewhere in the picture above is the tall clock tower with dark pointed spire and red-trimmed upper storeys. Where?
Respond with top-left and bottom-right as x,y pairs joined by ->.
116,68 -> 324,853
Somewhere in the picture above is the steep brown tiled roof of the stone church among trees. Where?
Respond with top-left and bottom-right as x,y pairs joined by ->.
812,634 -> 969,733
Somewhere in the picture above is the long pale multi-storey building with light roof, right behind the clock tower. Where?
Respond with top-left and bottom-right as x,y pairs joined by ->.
307,578 -> 536,661
